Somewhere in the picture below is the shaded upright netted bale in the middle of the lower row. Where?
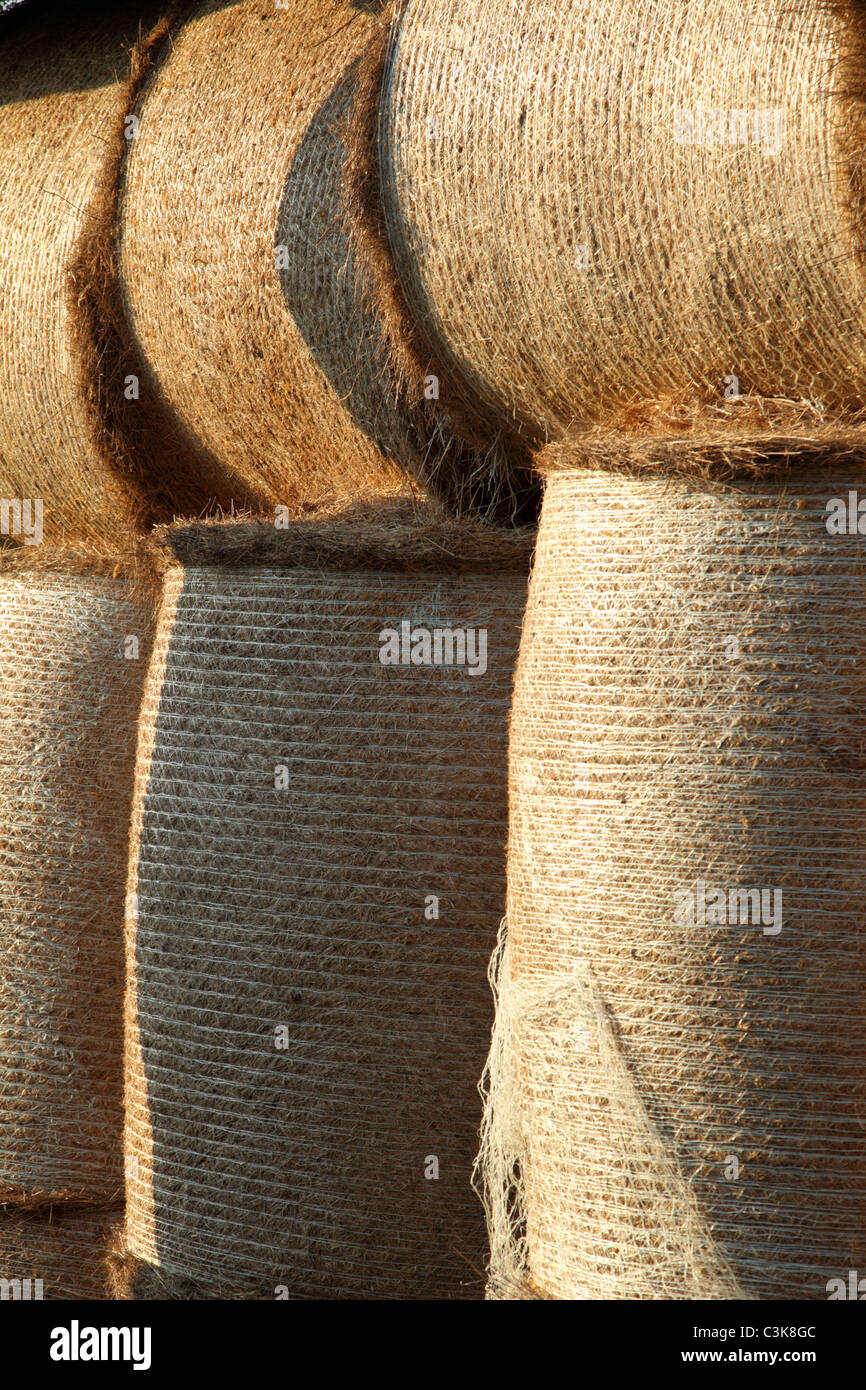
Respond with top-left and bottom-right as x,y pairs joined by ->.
125,510 -> 531,1298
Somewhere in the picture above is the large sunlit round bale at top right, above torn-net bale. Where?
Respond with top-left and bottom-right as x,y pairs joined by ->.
382,0 -> 866,439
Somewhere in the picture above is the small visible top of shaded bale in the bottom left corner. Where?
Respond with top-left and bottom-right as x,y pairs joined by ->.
0,1207 -> 124,1302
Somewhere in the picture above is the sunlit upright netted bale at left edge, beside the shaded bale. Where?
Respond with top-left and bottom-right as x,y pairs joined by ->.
0,548 -> 152,1205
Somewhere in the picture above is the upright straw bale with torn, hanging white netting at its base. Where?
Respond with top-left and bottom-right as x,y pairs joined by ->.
481,468 -> 866,1300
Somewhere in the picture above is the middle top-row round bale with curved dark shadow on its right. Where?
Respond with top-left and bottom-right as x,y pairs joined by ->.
121,0 -> 433,505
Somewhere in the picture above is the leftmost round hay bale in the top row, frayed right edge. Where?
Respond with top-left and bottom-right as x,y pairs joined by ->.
0,4 -> 189,549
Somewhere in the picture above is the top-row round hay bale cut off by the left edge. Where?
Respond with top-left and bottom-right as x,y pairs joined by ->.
0,3 -> 232,552
